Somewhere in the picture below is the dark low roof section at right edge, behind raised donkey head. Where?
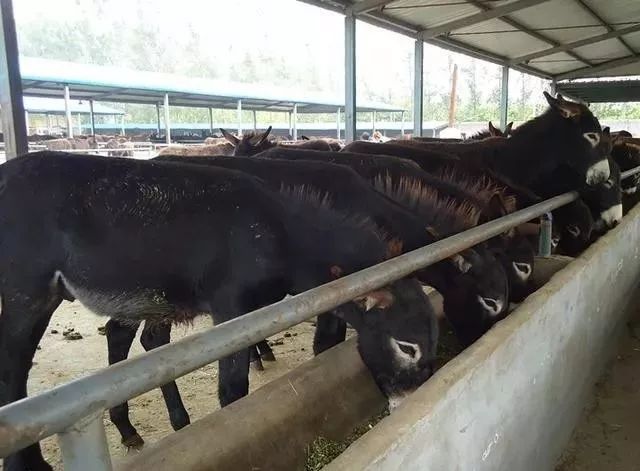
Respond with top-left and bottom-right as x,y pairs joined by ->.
556,79 -> 640,103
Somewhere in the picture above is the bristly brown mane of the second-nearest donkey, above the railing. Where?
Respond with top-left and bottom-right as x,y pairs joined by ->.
373,173 -> 481,235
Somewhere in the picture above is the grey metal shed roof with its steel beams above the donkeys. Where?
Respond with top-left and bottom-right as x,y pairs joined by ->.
300,0 -> 640,80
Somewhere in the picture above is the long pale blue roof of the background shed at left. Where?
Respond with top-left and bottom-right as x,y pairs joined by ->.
20,57 -> 404,113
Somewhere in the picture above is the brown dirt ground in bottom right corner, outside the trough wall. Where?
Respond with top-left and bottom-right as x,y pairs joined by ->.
556,310 -> 640,471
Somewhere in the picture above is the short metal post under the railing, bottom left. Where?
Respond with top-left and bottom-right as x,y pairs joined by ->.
58,411 -> 112,471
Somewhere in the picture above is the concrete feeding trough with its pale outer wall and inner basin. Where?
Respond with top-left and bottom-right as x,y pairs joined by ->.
118,208 -> 640,471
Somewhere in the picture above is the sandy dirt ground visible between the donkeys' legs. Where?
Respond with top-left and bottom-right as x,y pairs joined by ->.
0,302 -> 314,471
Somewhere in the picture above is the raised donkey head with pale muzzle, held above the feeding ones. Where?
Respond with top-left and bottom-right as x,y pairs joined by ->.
544,92 -> 611,185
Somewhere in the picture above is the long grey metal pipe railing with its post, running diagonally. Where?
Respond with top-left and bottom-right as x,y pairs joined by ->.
0,167 -> 640,471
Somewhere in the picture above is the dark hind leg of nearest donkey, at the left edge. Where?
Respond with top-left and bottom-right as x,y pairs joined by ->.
0,287 -> 61,471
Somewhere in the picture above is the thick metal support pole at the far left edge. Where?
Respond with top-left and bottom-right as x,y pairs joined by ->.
0,0 -> 29,159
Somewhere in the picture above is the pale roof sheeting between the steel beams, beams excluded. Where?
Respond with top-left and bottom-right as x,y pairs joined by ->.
300,0 -> 640,79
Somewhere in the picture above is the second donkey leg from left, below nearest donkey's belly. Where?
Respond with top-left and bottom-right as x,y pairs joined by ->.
105,319 -> 144,448
